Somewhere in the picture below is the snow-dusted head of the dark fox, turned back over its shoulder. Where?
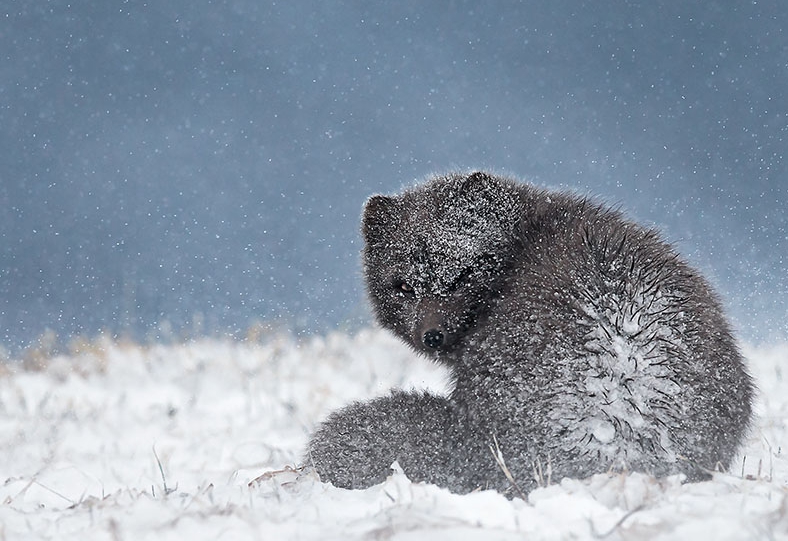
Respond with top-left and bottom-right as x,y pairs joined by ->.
362,172 -> 522,354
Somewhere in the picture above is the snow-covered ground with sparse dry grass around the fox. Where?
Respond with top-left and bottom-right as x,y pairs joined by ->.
0,331 -> 788,541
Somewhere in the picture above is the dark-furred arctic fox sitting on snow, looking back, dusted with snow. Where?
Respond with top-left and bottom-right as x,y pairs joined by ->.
304,172 -> 753,495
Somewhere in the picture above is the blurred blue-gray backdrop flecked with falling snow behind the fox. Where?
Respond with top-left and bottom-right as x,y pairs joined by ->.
0,0 -> 788,350
